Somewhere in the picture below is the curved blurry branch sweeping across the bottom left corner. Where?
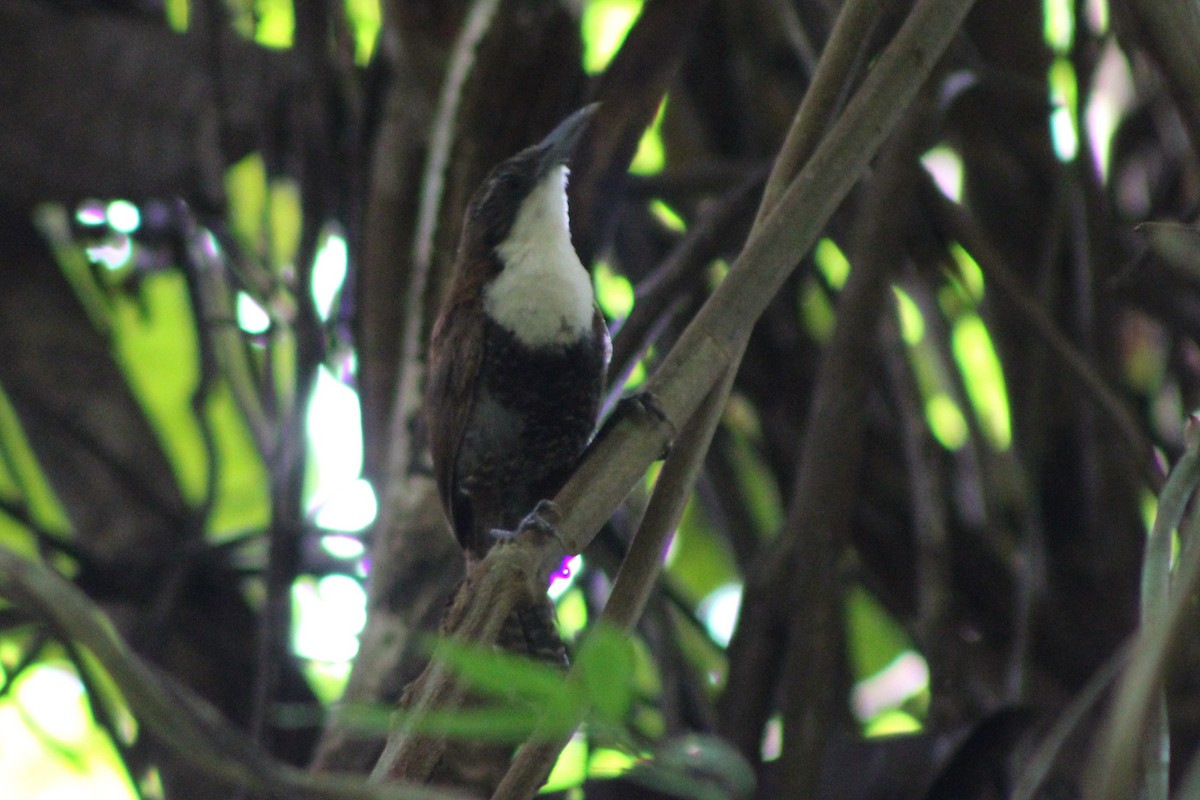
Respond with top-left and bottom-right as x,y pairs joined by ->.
0,548 -> 464,800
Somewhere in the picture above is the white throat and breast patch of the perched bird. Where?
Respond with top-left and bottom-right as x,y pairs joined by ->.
484,166 -> 595,347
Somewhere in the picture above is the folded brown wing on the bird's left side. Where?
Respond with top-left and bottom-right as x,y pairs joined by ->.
425,291 -> 484,540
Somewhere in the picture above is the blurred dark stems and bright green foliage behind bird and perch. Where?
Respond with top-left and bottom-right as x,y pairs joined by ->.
0,0 -> 1200,800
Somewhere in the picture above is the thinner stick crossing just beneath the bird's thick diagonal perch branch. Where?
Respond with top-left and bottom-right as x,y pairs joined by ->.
492,369 -> 737,800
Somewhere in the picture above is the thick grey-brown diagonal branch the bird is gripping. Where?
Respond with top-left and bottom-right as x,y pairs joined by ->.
380,0 -> 973,786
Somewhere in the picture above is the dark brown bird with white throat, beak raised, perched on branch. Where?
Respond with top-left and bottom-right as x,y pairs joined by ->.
425,104 -> 612,565
